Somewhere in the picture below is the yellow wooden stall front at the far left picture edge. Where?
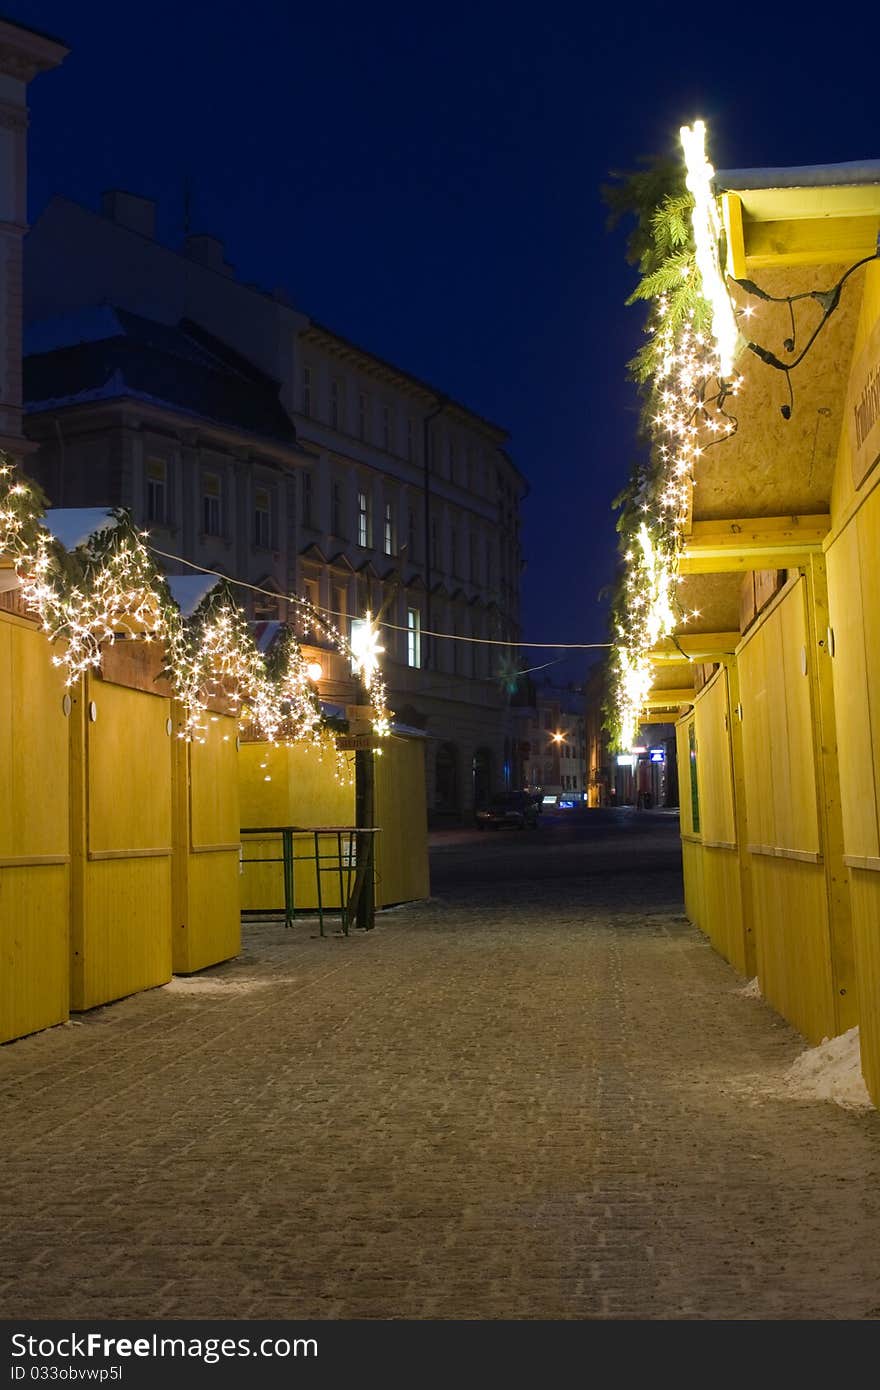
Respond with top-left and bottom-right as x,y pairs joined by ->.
0,610 -> 70,1043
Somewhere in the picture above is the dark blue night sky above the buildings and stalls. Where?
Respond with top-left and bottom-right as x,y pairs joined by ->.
4,0 -> 880,677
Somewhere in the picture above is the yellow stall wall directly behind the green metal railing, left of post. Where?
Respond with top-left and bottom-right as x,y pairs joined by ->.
239,742 -> 355,912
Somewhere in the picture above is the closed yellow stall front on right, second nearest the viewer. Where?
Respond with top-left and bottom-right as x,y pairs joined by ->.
737,575 -> 855,1043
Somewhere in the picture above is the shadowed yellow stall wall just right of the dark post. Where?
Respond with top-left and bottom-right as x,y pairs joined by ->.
374,735 -> 431,908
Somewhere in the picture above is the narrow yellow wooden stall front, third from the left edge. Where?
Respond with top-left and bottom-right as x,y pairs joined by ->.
172,714 -> 242,974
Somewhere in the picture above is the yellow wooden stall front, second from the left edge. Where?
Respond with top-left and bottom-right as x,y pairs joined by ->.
71,642 -> 174,1009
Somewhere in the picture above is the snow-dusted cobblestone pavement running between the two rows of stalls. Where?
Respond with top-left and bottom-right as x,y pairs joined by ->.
0,815 -> 880,1319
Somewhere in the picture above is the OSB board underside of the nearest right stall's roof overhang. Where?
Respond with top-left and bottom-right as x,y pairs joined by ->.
694,265 -> 865,521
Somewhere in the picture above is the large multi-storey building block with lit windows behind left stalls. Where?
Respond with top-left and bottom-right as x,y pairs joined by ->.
26,190 -> 525,819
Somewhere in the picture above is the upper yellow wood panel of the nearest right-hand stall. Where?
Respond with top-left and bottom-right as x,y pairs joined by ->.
827,522 -> 880,858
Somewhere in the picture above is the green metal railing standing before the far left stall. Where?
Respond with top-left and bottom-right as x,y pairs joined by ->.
241,826 -> 380,937
